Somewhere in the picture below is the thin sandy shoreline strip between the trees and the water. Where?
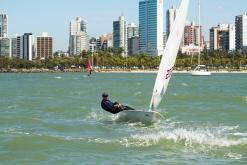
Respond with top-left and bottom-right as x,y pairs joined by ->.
0,69 -> 247,74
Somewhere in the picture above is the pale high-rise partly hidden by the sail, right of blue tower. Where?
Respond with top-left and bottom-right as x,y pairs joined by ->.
166,5 -> 177,38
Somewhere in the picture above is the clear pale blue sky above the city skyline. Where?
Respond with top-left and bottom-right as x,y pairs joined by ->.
0,0 -> 247,51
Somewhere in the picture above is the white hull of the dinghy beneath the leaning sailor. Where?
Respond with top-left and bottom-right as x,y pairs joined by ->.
116,110 -> 163,124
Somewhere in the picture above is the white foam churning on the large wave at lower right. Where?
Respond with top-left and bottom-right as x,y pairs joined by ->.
128,125 -> 247,147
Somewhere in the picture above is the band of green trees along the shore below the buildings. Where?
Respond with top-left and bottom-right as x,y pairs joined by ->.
0,49 -> 247,70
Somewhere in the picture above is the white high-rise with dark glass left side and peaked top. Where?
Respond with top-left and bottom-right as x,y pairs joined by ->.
113,16 -> 128,56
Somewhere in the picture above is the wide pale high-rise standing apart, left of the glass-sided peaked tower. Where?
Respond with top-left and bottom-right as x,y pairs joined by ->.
69,17 -> 89,55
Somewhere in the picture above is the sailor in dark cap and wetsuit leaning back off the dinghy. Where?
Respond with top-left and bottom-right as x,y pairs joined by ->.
101,92 -> 135,114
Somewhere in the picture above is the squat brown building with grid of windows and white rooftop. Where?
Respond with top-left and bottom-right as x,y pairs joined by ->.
36,33 -> 53,59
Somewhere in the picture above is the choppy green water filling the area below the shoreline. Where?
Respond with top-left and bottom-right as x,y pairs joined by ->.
0,73 -> 247,165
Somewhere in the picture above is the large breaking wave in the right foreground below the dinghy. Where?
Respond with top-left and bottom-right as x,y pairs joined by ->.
111,122 -> 247,148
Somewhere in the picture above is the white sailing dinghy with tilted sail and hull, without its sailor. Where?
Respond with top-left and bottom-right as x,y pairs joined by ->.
117,0 -> 189,124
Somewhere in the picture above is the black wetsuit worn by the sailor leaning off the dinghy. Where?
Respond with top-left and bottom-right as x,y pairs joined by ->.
101,99 -> 134,114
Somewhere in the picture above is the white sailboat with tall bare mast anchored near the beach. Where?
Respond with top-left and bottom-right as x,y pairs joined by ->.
191,0 -> 211,76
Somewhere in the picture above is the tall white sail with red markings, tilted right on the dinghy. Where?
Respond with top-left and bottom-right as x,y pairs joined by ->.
150,0 -> 189,111
